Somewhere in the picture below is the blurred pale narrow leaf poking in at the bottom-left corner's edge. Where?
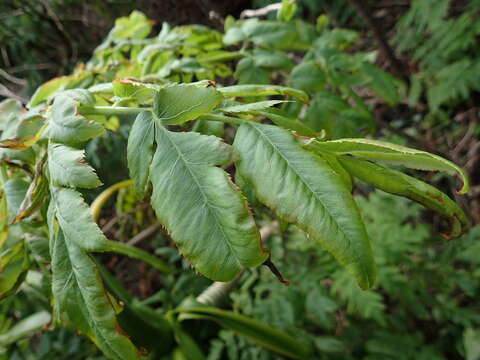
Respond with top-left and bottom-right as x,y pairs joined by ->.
0,311 -> 51,347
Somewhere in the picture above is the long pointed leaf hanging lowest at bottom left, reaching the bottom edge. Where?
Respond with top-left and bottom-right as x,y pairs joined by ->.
50,225 -> 139,360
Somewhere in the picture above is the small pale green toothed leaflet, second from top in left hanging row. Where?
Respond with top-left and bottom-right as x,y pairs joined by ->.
48,142 -> 102,189
